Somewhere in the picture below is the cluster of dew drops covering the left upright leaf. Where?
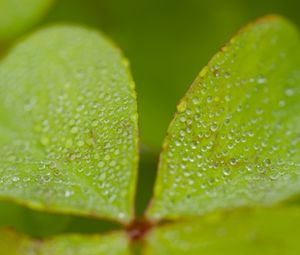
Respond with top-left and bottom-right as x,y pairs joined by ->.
1,62 -> 136,218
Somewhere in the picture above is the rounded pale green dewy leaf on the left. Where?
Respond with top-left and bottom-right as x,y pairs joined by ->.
0,24 -> 138,221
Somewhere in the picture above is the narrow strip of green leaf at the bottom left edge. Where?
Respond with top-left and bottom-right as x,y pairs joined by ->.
0,230 -> 130,255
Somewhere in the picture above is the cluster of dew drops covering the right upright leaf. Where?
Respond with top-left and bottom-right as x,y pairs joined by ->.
161,58 -> 300,208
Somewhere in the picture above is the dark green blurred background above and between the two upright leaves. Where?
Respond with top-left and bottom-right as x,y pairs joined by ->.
0,0 -> 300,235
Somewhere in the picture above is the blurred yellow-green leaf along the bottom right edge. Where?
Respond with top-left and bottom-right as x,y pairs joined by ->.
144,207 -> 300,255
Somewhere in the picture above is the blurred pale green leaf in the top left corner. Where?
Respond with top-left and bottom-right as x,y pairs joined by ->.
0,0 -> 54,40
